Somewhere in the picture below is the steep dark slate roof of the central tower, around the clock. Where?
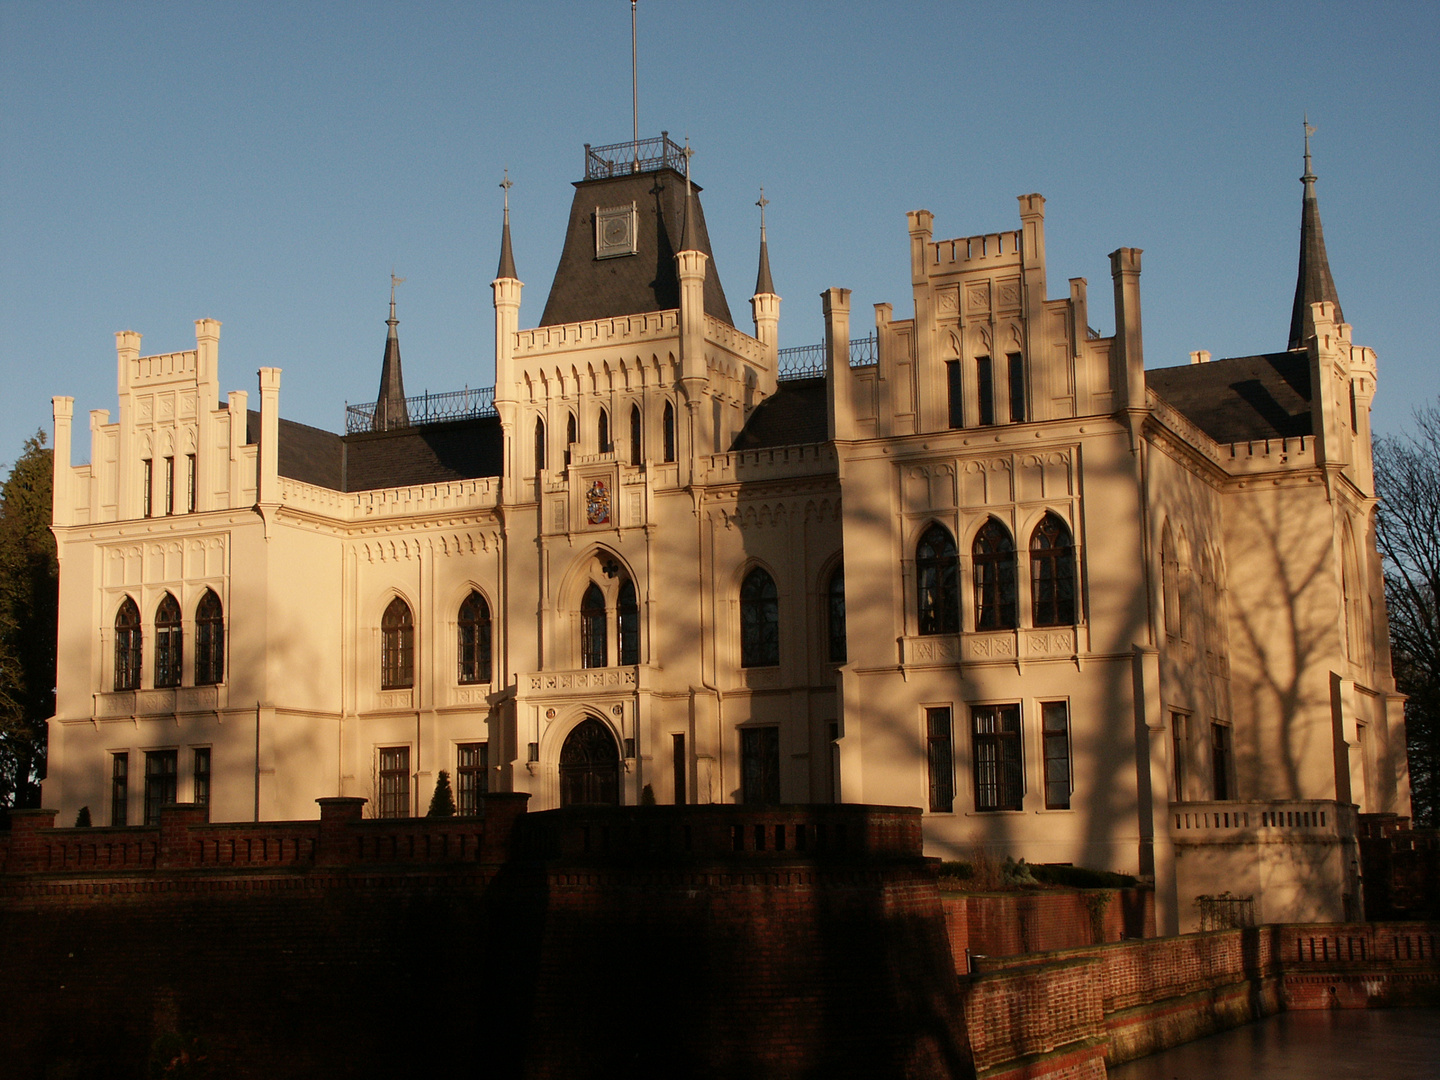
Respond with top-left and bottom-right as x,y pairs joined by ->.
540,168 -> 734,327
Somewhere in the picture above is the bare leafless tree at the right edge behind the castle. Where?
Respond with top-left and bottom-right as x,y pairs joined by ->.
1375,400 -> 1440,825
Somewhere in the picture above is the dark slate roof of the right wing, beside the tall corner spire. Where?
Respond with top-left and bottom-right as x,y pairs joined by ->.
1145,351 -> 1315,444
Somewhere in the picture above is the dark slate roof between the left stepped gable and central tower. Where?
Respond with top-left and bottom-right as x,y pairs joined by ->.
245,409 -> 504,491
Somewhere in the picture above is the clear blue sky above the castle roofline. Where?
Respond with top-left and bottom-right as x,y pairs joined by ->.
0,0 -> 1440,462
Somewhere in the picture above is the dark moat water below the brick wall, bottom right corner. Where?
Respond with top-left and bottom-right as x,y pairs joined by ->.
1109,1008 -> 1440,1080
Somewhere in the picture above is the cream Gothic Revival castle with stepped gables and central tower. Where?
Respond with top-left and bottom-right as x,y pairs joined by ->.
45,135 -> 1410,932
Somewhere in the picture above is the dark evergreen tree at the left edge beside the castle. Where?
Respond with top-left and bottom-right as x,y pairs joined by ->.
0,432 -> 59,806
